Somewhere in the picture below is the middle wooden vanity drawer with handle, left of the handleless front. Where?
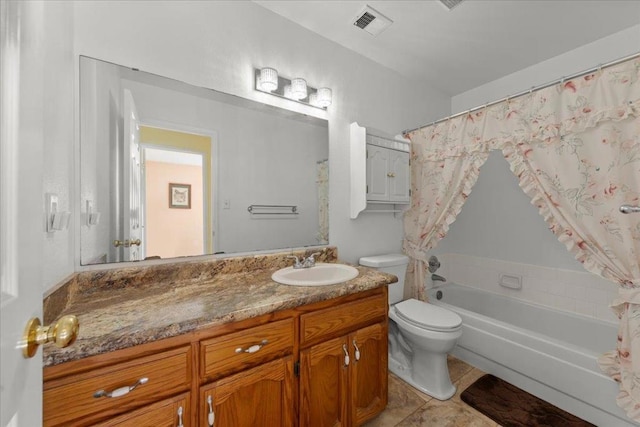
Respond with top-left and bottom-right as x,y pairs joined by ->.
200,319 -> 294,380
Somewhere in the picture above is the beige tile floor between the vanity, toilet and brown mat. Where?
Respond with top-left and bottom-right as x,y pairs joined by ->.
364,356 -> 500,427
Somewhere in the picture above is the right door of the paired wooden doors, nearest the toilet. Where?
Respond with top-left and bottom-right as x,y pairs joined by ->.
349,322 -> 388,425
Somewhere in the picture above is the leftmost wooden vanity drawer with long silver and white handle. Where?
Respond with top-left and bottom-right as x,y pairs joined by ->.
43,347 -> 192,426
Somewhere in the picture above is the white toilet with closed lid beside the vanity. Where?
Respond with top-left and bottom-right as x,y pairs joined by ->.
360,254 -> 462,400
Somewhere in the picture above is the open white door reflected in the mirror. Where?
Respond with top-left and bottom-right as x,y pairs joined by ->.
122,89 -> 145,261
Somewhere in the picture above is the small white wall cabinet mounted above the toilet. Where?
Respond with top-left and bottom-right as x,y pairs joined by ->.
350,122 -> 411,219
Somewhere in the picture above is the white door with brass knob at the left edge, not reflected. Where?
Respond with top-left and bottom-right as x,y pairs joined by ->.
0,0 -> 47,427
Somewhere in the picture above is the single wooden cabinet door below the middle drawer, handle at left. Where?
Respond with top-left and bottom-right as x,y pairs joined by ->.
199,356 -> 294,427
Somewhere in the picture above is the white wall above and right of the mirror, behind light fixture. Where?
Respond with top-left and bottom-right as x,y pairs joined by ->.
75,1 -> 450,268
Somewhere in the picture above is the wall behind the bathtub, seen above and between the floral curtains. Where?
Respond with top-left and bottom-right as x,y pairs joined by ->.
434,25 -> 640,320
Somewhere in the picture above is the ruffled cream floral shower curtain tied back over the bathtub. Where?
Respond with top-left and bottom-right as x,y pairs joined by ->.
404,56 -> 640,421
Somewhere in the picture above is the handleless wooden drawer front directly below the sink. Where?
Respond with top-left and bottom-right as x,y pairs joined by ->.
300,293 -> 388,346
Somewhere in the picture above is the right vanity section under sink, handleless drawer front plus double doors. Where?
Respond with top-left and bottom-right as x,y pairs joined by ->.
300,289 -> 388,427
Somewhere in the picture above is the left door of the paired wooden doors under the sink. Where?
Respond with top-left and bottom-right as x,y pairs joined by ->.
300,337 -> 349,427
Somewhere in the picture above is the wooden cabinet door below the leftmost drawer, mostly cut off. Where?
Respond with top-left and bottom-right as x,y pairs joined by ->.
94,393 -> 191,427
